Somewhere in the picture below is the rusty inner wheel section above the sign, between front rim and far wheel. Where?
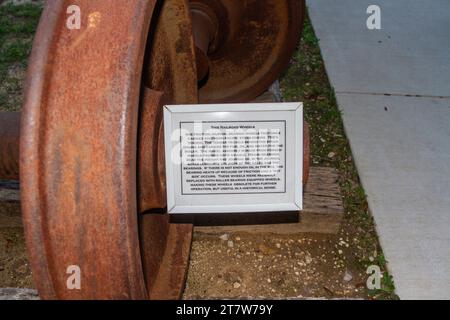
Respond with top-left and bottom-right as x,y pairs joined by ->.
144,0 -> 198,104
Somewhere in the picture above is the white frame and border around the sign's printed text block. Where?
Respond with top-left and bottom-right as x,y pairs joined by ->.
164,102 -> 303,214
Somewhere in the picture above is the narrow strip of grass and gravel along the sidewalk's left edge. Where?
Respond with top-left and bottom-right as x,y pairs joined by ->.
281,11 -> 397,299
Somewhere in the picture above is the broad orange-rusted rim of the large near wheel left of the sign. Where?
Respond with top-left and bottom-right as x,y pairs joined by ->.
20,0 -> 192,299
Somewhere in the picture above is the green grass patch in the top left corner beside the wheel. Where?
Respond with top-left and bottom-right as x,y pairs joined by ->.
0,3 -> 42,111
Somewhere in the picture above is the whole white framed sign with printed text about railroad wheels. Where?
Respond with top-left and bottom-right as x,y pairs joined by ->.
164,103 -> 303,214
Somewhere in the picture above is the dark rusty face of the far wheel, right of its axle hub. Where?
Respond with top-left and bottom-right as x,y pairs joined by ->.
195,0 -> 305,103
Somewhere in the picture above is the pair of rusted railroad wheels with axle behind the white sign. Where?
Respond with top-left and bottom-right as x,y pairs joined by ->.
0,0 -> 304,299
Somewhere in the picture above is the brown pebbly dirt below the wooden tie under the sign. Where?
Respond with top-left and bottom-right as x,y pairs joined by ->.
184,233 -> 367,299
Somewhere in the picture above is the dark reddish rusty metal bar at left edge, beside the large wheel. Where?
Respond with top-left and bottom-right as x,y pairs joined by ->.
0,112 -> 20,180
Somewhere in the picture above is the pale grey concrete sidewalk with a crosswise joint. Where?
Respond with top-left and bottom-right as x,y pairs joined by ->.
307,0 -> 450,299
